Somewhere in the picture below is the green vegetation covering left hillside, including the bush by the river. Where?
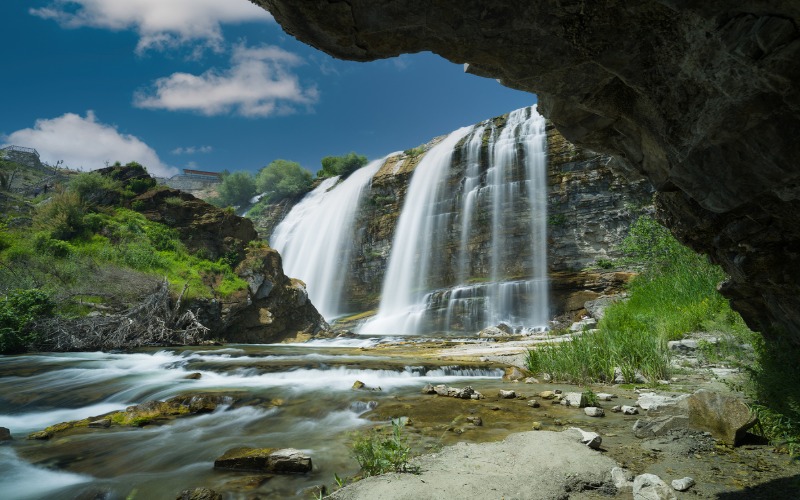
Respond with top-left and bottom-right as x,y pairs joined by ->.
0,160 -> 247,352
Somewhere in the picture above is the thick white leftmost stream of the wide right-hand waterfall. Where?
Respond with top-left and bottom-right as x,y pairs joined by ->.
359,127 -> 472,335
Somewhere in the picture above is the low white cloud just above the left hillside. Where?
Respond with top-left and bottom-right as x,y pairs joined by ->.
3,111 -> 178,177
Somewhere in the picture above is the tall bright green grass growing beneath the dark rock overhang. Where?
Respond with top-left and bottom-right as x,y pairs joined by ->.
527,216 -> 752,383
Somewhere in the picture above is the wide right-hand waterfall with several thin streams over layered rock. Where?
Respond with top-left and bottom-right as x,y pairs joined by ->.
360,107 -> 549,335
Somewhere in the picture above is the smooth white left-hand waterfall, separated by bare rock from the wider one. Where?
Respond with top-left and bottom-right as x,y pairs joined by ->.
270,158 -> 386,320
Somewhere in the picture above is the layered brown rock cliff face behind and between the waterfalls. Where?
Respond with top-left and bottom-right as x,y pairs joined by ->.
256,116 -> 652,324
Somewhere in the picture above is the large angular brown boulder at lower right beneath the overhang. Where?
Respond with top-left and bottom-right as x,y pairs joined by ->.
688,389 -> 758,446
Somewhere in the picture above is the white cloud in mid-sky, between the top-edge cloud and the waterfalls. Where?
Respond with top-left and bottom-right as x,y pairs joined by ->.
134,45 -> 319,117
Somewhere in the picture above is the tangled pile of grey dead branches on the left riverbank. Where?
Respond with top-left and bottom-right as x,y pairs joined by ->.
34,279 -> 209,351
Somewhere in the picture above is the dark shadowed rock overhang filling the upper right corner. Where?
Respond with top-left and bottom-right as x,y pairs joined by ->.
254,0 -> 800,342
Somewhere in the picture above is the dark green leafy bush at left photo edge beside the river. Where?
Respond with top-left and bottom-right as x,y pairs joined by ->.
0,289 -> 54,354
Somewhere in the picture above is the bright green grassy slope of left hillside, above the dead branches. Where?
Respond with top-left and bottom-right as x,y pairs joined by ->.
0,165 -> 246,352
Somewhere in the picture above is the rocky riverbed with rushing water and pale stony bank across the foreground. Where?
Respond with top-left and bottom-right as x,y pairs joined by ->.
0,334 -> 800,498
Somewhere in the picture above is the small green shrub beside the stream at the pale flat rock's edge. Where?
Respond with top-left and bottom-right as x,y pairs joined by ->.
352,421 -> 412,477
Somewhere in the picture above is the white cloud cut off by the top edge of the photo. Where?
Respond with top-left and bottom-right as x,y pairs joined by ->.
29,0 -> 272,53
